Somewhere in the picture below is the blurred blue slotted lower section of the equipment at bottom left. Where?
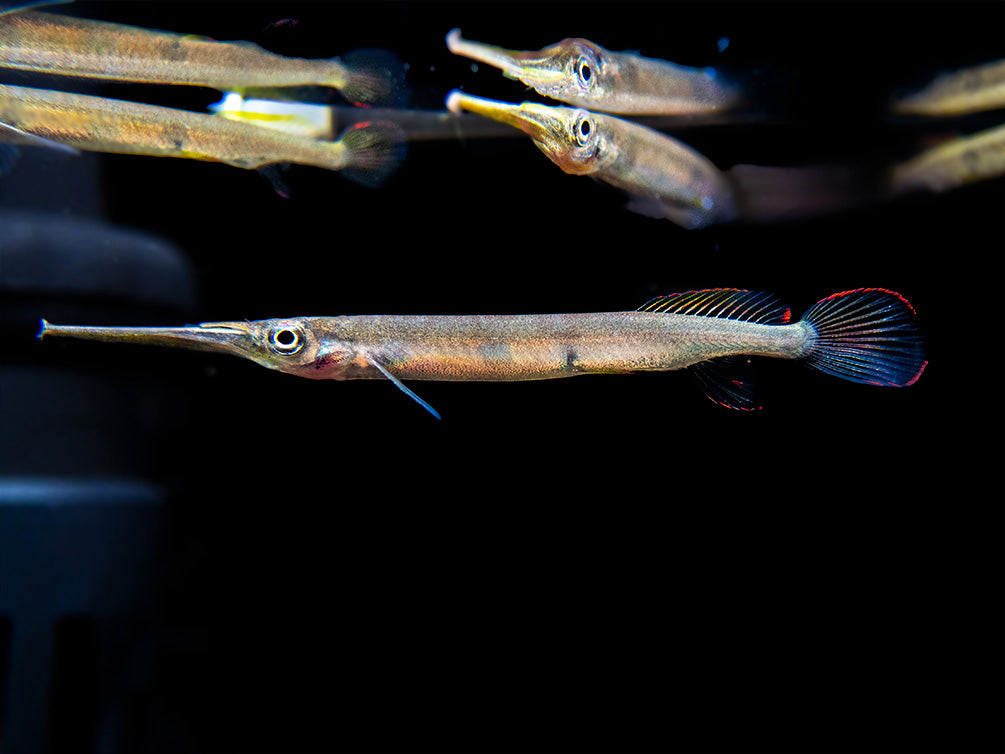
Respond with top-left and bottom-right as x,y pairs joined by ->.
0,477 -> 163,753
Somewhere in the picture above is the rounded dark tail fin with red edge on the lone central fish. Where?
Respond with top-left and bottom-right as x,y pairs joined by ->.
802,288 -> 928,387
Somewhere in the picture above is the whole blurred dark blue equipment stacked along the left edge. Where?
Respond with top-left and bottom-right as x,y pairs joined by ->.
0,211 -> 194,754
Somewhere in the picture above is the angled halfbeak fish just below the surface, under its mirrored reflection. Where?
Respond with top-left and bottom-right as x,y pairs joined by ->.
446,89 -> 737,228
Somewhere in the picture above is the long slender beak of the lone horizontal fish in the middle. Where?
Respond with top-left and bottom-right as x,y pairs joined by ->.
38,320 -> 255,357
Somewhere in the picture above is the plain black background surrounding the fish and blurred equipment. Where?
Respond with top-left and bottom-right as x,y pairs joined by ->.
1,2 -> 1005,751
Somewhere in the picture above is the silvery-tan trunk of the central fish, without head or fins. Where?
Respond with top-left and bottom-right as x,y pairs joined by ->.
294,312 -> 813,381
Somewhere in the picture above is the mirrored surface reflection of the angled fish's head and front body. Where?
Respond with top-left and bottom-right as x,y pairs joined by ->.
446,29 -> 742,115
